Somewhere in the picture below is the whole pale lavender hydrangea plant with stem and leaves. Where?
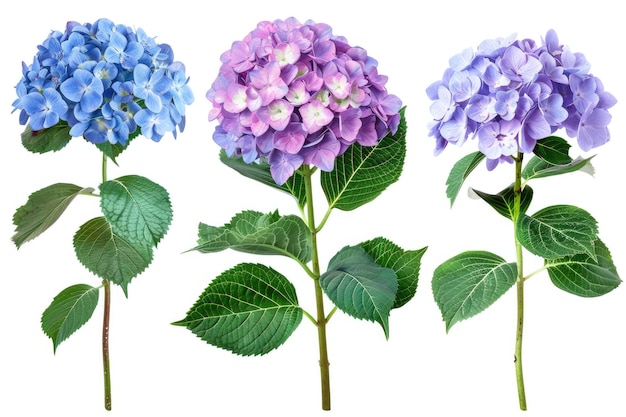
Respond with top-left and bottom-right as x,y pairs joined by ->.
427,30 -> 621,410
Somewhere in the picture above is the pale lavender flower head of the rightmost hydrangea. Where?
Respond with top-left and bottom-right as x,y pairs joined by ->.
427,30 -> 616,170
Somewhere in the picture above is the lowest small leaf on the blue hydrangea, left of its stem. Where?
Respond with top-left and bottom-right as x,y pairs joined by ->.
41,284 -> 99,352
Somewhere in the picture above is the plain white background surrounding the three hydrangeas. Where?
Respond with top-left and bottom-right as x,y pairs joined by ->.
0,0 -> 626,417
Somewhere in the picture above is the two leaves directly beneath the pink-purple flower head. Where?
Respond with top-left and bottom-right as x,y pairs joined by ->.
220,108 -> 407,211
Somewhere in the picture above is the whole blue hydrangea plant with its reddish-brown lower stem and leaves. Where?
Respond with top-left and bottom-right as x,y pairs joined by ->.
13,19 -> 193,409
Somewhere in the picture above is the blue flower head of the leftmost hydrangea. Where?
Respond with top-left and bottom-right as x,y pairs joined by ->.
13,19 -> 193,145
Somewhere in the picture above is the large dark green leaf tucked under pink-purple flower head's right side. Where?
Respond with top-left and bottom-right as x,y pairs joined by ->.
321,108 -> 406,211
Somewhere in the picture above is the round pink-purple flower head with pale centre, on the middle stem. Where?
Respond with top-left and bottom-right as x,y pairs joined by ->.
207,18 -> 402,185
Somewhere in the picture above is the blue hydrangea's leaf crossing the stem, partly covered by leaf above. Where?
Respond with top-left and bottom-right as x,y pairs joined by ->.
74,217 -> 152,295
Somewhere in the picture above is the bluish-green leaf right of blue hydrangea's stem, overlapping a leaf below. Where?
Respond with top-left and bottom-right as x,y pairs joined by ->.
100,175 -> 172,246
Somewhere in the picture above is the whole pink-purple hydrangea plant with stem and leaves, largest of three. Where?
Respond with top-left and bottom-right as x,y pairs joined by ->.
175,18 -> 426,410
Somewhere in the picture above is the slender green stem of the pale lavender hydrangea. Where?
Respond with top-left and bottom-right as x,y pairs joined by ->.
513,153 -> 526,410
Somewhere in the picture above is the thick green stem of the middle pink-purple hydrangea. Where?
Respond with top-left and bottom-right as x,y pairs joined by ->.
302,165 -> 330,410
